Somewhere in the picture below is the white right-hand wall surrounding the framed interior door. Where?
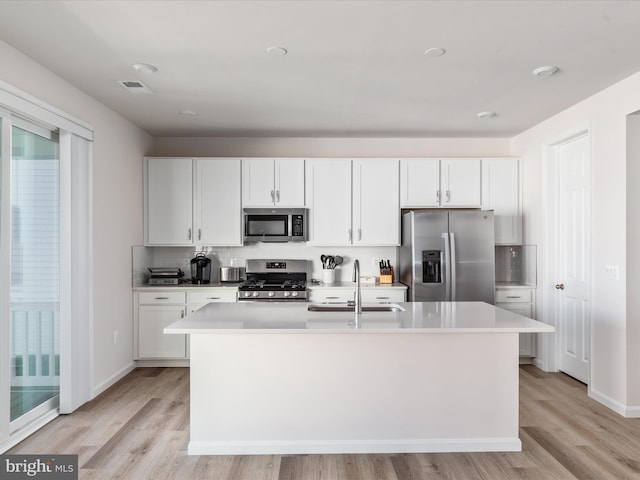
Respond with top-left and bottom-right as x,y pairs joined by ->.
511,69 -> 640,414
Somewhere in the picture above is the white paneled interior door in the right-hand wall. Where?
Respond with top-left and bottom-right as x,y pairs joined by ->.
553,134 -> 591,383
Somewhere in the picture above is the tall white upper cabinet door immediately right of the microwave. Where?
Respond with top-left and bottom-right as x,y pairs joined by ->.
306,159 -> 352,245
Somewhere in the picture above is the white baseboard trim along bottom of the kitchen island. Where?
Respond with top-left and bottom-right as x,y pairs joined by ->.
188,437 -> 522,455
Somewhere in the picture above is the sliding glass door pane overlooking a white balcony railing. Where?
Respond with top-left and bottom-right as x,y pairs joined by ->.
10,123 -> 60,424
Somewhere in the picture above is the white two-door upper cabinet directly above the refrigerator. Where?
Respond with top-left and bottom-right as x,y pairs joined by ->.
400,158 -> 481,208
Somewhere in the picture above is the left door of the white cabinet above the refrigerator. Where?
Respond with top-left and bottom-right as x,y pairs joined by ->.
400,158 -> 440,208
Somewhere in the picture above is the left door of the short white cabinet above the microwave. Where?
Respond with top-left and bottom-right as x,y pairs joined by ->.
242,158 -> 276,207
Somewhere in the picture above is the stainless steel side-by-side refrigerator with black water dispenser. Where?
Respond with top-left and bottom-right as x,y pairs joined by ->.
398,210 -> 495,305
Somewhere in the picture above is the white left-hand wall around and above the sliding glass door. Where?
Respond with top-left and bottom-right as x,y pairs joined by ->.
0,41 -> 152,390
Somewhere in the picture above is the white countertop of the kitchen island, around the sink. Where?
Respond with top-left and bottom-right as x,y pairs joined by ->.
164,302 -> 555,334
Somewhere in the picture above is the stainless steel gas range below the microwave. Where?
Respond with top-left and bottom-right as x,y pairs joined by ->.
238,260 -> 307,302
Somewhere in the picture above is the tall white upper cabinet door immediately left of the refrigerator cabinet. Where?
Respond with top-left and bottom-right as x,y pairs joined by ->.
353,159 -> 400,245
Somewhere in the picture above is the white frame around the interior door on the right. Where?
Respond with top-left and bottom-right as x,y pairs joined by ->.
534,125 -> 593,376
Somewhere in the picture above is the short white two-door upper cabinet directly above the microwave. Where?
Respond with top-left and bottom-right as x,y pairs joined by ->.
242,158 -> 305,207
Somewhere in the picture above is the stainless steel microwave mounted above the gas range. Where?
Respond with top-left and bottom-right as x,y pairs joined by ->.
243,208 -> 307,243
